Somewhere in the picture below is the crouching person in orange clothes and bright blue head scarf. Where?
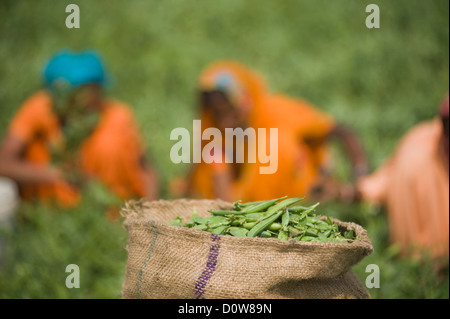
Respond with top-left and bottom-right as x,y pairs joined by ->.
0,51 -> 158,206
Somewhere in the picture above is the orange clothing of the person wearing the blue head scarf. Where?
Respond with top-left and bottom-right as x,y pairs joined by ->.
9,91 -> 145,206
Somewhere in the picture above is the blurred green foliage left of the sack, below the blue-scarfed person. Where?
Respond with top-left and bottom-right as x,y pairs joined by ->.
0,183 -> 127,298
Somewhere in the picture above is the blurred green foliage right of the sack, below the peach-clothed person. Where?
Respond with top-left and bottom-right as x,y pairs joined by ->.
322,203 -> 449,299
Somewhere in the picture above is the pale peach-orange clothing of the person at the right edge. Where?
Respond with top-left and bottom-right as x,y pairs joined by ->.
359,119 -> 449,258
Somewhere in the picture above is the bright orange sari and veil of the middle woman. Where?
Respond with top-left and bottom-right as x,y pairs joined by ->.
192,61 -> 335,201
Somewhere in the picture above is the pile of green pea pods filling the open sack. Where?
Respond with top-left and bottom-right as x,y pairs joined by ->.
170,196 -> 356,242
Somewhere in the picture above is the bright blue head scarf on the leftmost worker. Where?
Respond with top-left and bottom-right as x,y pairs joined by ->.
43,50 -> 108,91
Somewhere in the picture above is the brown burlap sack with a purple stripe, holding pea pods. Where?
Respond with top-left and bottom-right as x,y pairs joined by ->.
122,199 -> 373,299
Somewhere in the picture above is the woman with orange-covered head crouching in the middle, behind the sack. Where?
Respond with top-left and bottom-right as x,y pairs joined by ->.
179,61 -> 367,201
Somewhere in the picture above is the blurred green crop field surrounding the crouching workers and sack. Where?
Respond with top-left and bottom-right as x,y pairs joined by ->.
0,0 -> 449,298
